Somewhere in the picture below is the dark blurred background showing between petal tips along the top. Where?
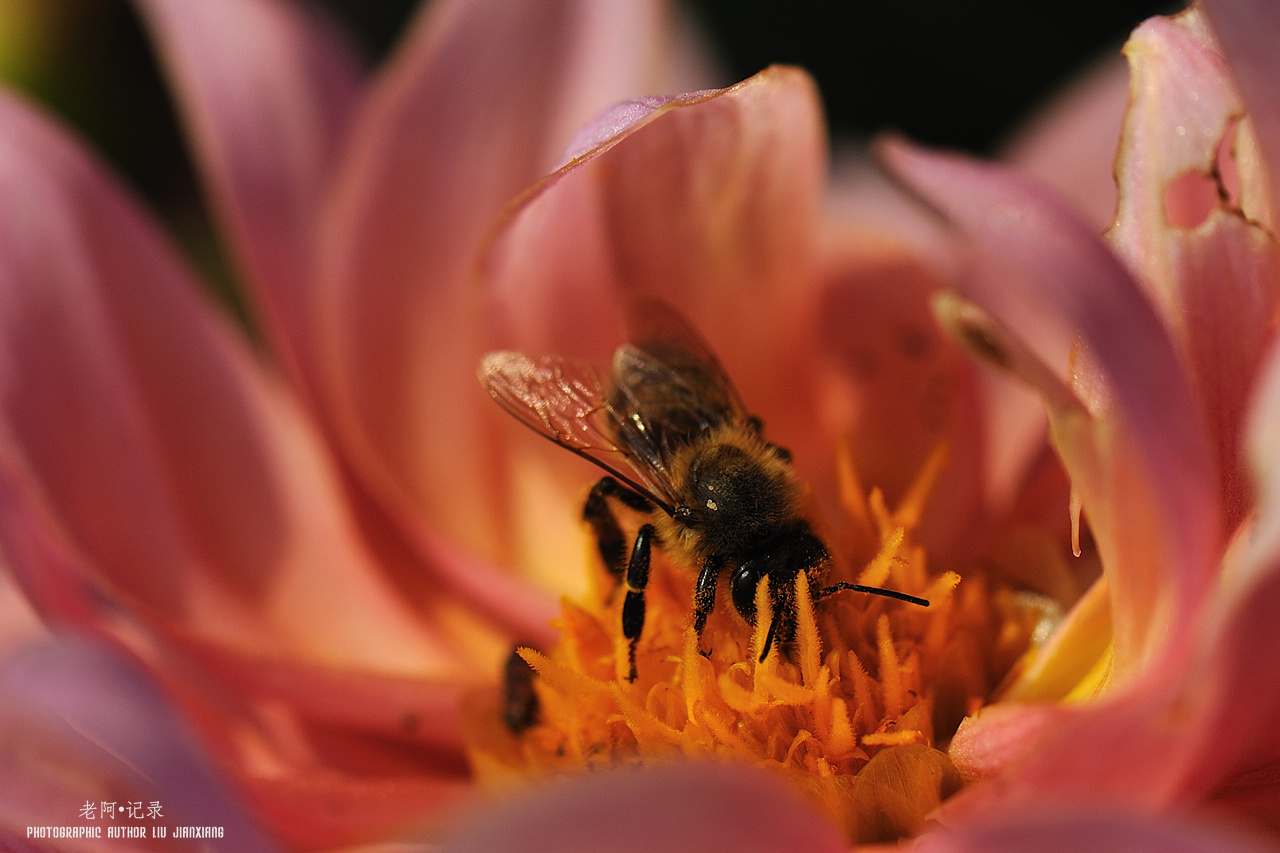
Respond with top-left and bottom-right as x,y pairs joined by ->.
0,0 -> 1171,302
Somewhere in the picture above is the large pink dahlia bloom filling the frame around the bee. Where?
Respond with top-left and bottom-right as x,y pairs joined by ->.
0,0 -> 1280,850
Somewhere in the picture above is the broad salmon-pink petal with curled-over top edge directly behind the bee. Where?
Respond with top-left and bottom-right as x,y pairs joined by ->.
485,68 -> 832,568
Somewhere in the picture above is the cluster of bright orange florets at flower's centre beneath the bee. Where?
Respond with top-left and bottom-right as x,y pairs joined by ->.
463,451 -> 1041,841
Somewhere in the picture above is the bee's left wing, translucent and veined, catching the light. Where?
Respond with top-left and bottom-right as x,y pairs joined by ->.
480,352 -> 680,514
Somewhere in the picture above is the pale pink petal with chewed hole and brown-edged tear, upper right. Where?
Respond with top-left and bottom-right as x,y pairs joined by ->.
1108,10 -> 1280,529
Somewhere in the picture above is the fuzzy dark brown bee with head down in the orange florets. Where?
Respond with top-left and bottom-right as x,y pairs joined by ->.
479,300 -> 929,681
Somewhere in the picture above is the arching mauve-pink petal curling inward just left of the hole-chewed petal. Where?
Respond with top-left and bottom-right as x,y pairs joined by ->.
886,139 -> 1221,680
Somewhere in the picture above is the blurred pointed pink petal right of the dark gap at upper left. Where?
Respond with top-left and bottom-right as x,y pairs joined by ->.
138,0 -> 357,381
